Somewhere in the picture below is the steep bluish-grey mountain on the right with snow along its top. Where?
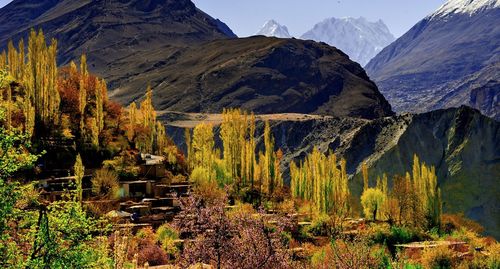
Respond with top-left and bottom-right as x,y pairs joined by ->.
366,0 -> 500,120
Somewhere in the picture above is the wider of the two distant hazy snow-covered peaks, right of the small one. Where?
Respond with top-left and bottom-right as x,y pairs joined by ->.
301,17 -> 394,66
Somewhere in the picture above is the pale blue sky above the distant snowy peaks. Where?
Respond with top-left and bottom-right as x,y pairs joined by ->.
0,0 -> 445,37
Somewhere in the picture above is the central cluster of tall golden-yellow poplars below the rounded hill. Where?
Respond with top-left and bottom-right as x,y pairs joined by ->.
185,109 -> 283,197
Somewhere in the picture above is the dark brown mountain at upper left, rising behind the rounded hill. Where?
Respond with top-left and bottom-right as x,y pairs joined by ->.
0,0 -> 236,63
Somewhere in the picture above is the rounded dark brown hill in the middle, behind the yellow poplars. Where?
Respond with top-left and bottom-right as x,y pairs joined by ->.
110,36 -> 393,119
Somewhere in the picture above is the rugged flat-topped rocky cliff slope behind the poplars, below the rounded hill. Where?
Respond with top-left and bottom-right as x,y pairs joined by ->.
164,107 -> 500,238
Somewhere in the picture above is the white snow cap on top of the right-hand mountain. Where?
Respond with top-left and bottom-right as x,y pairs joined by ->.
431,0 -> 500,17
